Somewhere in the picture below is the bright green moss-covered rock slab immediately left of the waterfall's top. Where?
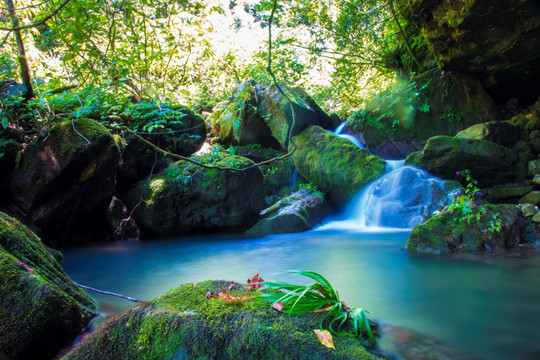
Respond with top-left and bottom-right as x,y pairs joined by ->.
292,126 -> 386,208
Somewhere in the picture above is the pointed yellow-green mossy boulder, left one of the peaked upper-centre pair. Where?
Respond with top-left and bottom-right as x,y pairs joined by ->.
209,80 -> 280,149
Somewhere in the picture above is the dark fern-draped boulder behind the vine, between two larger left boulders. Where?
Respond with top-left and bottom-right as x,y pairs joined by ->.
117,105 -> 207,193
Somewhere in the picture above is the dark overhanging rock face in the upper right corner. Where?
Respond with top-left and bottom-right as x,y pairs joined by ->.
397,0 -> 540,104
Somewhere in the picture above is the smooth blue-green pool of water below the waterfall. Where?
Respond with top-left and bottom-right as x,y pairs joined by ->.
63,230 -> 540,360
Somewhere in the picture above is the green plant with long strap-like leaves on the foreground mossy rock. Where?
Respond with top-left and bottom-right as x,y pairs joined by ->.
259,270 -> 375,341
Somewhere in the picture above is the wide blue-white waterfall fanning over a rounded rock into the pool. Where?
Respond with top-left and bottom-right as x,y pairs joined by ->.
317,160 -> 454,230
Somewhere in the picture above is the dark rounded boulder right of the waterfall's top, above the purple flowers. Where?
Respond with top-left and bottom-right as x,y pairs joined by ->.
405,136 -> 524,187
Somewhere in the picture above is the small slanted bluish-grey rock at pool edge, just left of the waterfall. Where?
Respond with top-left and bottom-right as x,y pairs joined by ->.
247,188 -> 330,234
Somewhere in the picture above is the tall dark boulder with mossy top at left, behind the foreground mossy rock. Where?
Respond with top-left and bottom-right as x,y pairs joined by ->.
11,119 -> 120,245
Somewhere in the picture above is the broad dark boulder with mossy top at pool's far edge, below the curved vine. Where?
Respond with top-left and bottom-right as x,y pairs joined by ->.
126,152 -> 264,236
